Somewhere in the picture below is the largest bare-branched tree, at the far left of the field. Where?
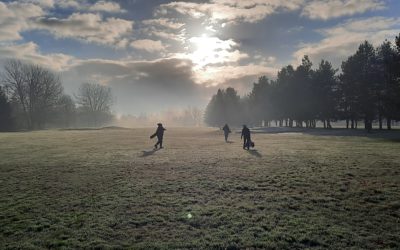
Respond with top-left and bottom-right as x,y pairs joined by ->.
2,60 -> 63,129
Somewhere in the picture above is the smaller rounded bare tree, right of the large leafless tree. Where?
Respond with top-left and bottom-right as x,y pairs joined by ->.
75,83 -> 113,126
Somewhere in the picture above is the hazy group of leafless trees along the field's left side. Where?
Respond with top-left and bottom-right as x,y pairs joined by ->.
0,60 -> 113,131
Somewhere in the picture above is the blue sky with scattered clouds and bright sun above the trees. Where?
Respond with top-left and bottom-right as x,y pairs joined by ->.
0,0 -> 400,115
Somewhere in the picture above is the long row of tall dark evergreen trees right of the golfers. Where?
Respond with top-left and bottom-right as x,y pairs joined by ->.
204,35 -> 400,130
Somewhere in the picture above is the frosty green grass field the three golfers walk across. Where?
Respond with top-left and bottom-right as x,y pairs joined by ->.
0,128 -> 400,249
